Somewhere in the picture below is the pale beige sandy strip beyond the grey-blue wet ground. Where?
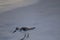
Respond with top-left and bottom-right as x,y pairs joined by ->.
0,0 -> 38,13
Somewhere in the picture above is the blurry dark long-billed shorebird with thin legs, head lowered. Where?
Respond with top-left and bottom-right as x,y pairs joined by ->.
13,27 -> 35,40
